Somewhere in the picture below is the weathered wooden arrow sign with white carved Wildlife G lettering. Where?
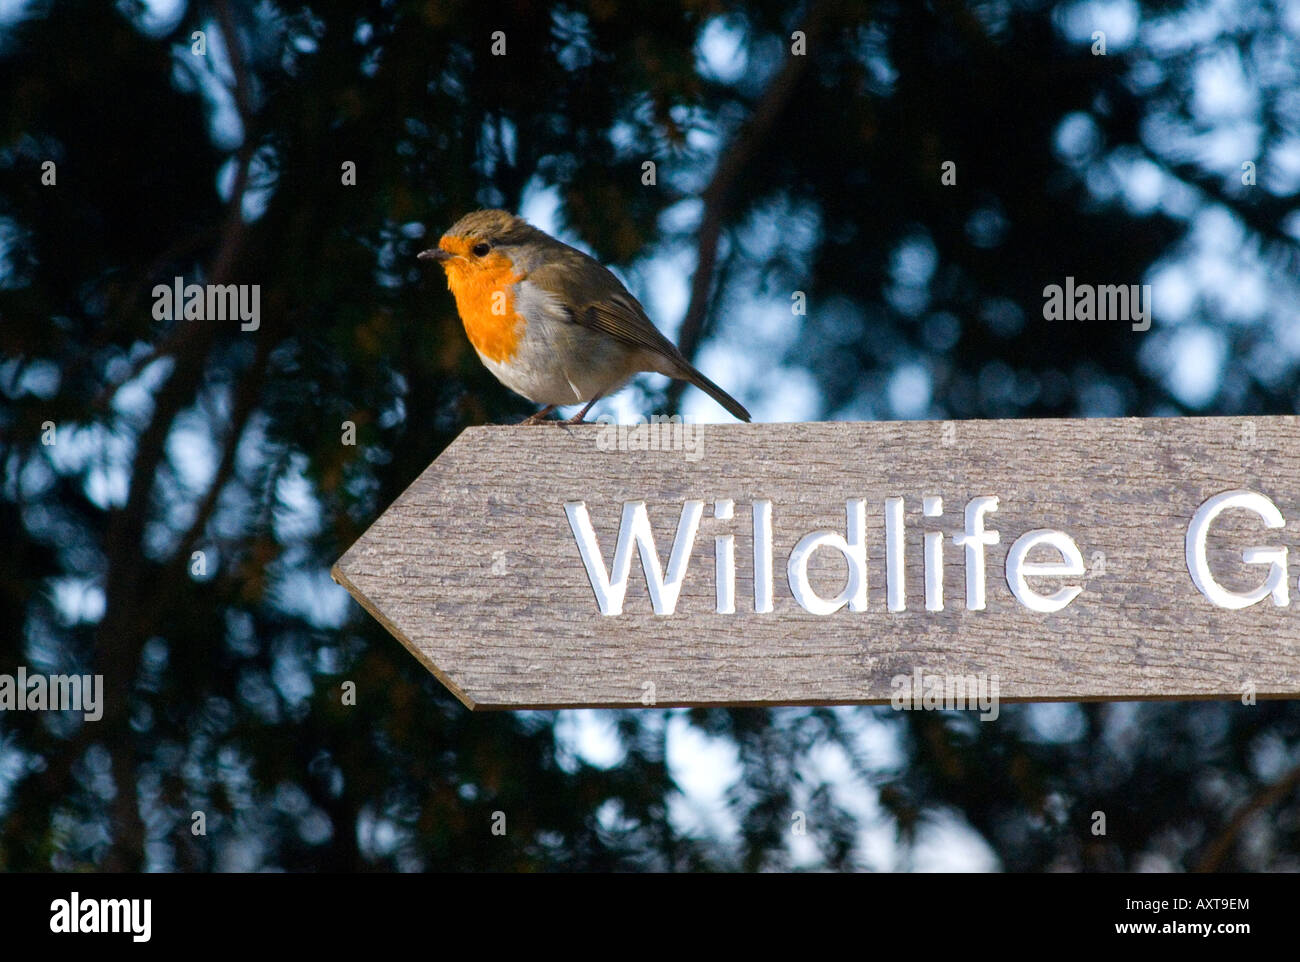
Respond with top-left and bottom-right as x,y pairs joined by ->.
333,417 -> 1300,709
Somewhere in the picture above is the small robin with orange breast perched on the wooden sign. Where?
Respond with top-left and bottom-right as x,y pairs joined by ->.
419,211 -> 749,424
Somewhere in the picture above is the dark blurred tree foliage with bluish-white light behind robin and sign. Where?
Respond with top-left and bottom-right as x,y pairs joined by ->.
0,0 -> 1300,871
